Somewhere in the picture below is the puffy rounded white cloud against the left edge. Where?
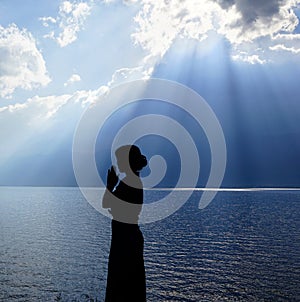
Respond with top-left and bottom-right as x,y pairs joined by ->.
0,24 -> 50,98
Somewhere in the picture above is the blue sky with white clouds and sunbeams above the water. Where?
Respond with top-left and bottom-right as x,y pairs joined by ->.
0,0 -> 300,187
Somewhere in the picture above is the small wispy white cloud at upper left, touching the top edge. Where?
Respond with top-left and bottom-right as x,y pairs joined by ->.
40,1 -> 92,47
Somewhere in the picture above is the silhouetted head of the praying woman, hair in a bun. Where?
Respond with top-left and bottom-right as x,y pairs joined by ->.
116,145 -> 147,174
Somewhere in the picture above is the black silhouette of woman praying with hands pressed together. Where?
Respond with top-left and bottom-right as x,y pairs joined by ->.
102,145 -> 147,302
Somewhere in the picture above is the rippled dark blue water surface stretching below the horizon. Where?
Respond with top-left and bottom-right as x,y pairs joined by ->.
0,188 -> 300,302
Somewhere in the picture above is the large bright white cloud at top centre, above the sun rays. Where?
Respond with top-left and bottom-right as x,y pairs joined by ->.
132,0 -> 220,57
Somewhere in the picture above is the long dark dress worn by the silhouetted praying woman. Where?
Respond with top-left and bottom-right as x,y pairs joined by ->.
105,180 -> 146,302
